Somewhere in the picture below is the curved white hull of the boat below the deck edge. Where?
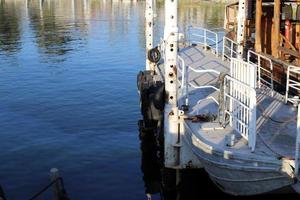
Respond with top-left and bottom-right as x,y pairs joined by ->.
184,122 -> 295,196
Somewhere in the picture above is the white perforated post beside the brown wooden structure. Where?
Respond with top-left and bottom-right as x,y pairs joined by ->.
237,0 -> 246,58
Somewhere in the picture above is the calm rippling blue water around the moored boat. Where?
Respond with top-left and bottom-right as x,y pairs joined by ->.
0,0 -> 224,200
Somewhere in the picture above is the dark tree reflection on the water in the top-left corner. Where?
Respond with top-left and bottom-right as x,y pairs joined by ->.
0,1 -> 21,53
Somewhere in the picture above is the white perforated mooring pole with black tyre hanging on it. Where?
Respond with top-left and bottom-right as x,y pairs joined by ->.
145,0 -> 155,71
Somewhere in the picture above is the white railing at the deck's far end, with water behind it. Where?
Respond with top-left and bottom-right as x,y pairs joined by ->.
188,26 -> 219,56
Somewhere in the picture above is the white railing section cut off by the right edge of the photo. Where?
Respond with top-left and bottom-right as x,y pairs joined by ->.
285,65 -> 300,104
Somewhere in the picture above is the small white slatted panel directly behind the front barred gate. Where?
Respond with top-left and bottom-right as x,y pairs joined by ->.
230,58 -> 256,88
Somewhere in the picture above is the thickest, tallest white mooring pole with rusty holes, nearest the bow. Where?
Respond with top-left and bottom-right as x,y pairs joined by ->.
164,0 -> 180,168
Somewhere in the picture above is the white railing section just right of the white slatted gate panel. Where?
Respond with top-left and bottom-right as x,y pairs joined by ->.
247,50 -> 274,95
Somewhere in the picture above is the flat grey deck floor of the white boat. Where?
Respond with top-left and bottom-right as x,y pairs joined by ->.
160,46 -> 297,159
